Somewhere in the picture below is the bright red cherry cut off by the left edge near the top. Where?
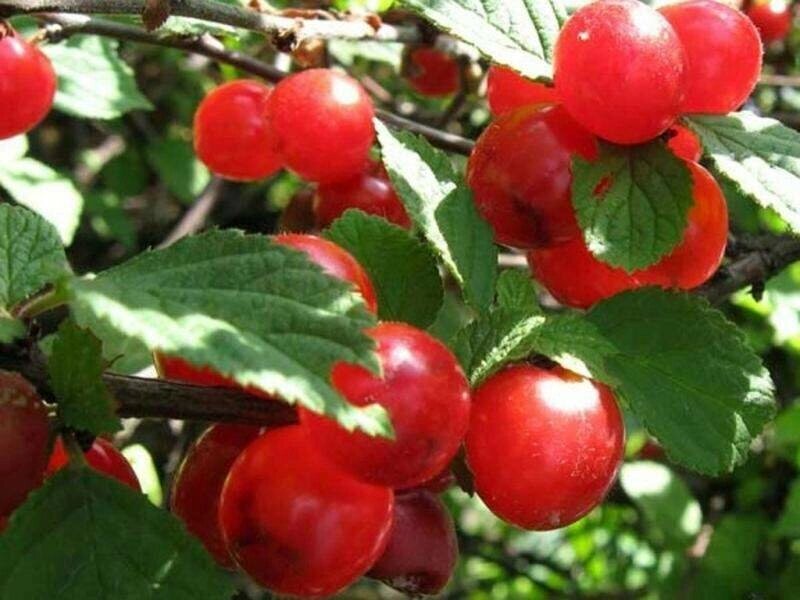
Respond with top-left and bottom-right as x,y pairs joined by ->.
0,30 -> 56,140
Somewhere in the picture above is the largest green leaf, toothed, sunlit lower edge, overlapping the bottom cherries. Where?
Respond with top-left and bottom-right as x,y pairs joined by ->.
72,230 -> 391,434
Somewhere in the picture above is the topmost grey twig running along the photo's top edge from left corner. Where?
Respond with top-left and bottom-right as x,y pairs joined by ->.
0,0 -> 420,48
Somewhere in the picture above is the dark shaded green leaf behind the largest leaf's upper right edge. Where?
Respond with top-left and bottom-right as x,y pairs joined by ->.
325,210 -> 443,329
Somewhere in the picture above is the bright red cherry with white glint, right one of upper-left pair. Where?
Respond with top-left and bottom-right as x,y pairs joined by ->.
266,69 -> 375,183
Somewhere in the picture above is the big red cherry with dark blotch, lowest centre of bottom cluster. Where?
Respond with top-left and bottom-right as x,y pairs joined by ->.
219,426 -> 393,597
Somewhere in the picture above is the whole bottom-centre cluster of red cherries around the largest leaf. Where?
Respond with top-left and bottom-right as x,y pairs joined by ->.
150,234 -> 624,596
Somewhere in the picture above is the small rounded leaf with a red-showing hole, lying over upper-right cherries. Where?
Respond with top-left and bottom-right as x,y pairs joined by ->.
572,141 -> 692,272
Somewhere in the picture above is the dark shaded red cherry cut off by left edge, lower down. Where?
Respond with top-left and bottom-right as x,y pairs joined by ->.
0,370 -> 50,515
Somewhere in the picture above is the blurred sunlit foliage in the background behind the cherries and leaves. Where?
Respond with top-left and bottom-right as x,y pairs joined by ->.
7,0 -> 800,600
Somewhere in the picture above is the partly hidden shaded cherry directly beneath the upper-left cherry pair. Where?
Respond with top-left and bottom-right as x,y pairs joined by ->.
314,161 -> 411,228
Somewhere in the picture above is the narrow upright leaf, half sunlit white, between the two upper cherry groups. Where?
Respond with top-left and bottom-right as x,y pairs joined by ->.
375,121 -> 497,310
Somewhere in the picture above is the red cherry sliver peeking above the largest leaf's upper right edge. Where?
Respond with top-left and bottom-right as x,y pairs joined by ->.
273,233 -> 378,313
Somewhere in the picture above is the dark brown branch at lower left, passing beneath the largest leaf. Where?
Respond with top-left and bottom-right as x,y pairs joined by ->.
0,351 -> 297,425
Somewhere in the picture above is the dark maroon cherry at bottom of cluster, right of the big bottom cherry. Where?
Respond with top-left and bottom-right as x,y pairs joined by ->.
367,491 -> 458,597
